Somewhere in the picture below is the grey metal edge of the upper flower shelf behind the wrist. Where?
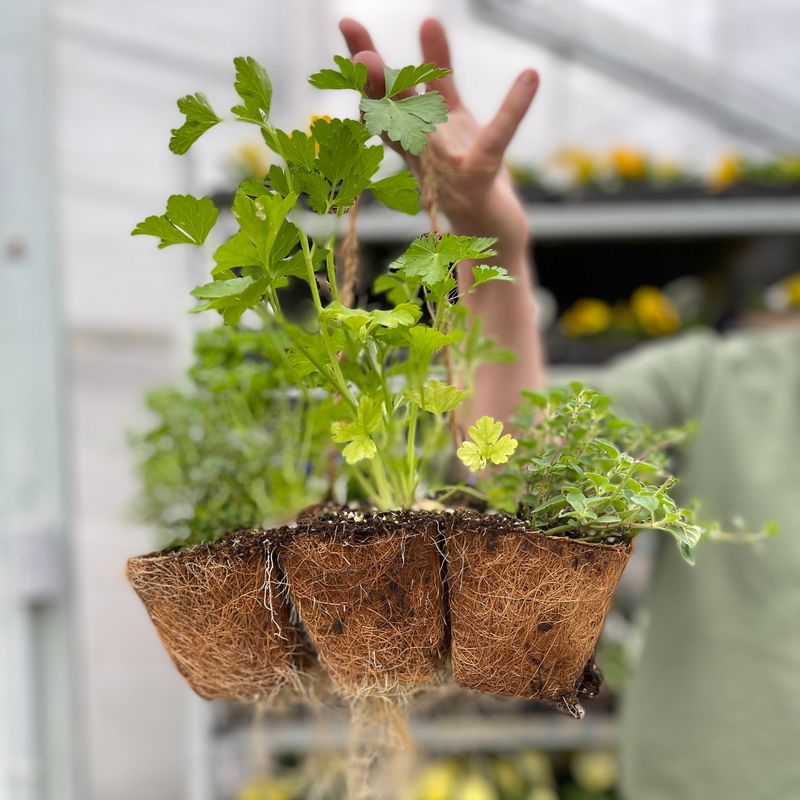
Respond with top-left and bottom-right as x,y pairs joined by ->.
296,198 -> 800,243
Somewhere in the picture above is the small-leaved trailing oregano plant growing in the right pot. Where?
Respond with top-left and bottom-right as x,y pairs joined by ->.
472,383 -> 774,563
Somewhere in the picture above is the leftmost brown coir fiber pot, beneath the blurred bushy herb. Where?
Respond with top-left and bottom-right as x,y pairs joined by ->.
127,531 -> 308,701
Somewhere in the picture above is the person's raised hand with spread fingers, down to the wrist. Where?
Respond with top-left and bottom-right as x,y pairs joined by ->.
339,19 -> 539,265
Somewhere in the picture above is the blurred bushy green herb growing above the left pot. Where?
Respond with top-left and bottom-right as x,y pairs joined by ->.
131,326 -> 334,544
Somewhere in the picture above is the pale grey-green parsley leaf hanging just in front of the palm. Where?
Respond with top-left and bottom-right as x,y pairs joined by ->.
360,92 -> 447,156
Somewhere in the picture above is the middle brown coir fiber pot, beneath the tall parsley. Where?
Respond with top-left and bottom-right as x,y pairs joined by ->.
280,511 -> 447,698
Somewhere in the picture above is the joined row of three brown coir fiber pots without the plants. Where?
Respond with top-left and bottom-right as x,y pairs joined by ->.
128,512 -> 630,708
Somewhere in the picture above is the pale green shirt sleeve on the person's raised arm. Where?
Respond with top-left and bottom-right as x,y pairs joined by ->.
592,331 -> 719,428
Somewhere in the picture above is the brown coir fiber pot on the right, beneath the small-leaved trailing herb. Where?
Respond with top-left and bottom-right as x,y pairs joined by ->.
446,515 -> 631,715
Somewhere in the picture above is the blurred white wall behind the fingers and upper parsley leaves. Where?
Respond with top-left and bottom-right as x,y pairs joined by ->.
54,0 -> 800,332
